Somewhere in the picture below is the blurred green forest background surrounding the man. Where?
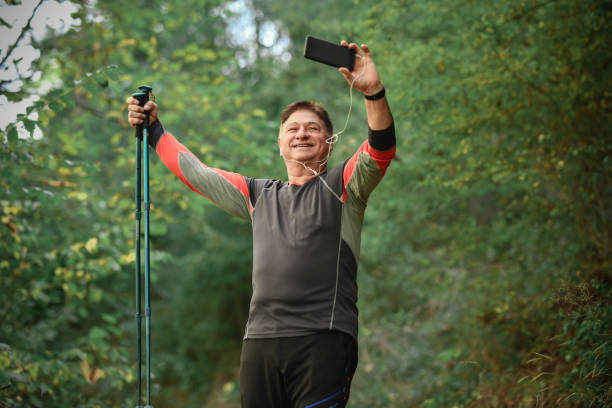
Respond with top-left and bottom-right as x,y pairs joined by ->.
0,0 -> 612,408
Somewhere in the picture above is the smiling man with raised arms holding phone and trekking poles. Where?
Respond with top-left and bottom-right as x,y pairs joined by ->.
127,41 -> 395,408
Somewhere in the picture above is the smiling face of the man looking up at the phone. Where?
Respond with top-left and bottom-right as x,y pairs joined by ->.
278,109 -> 329,164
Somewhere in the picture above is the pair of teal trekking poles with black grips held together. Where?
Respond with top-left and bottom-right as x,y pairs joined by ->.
132,86 -> 151,408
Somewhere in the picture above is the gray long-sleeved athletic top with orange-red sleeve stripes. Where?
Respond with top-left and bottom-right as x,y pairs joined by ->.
151,122 -> 395,339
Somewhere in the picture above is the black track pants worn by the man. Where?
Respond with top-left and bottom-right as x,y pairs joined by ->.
240,331 -> 357,408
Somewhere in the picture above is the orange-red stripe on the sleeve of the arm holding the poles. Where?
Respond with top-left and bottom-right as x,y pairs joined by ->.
155,132 -> 253,211
